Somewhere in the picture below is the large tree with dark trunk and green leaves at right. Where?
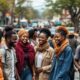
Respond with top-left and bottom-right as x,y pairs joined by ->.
46,0 -> 80,31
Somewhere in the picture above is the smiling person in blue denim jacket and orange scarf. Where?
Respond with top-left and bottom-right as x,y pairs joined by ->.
49,26 -> 74,80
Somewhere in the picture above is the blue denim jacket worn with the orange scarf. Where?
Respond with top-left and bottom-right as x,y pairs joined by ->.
49,46 -> 73,80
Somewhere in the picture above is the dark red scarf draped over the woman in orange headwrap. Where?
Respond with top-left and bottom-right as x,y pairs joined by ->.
15,41 -> 35,74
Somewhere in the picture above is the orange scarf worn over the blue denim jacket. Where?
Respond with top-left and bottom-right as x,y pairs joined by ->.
54,39 -> 69,57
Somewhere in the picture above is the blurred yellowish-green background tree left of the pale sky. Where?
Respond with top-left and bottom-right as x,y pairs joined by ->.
15,0 -> 39,19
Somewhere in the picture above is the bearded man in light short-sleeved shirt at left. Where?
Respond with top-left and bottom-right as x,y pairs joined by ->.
0,27 -> 17,80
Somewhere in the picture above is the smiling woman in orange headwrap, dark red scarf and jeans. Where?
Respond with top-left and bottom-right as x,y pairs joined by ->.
16,29 -> 35,80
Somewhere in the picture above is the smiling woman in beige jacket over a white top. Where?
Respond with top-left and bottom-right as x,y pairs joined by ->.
35,29 -> 54,80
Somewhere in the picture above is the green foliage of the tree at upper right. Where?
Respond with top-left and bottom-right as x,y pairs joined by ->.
46,0 -> 80,14
